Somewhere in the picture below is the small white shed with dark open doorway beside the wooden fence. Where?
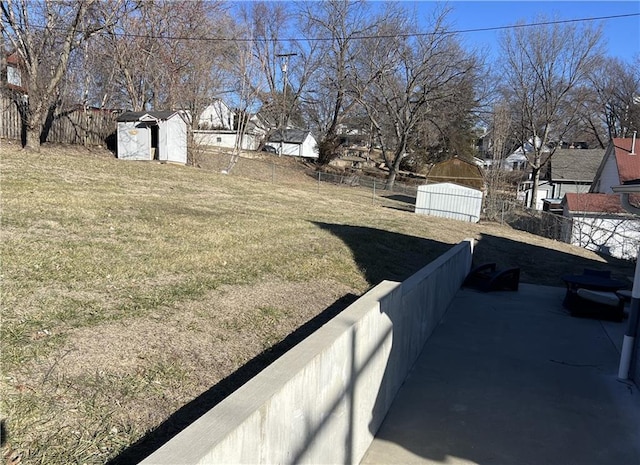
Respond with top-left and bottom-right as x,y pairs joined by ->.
117,110 -> 191,164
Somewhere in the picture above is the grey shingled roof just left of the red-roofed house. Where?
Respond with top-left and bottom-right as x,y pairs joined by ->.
549,149 -> 605,183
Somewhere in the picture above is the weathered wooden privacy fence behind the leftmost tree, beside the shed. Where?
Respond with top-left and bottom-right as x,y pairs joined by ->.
0,95 -> 119,146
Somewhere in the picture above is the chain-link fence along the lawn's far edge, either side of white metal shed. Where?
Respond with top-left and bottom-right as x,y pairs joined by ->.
193,150 -> 640,258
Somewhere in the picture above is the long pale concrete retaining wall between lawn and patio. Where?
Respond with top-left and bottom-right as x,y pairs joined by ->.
142,237 -> 473,465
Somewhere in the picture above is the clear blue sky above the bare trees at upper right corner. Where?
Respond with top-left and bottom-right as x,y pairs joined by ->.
404,0 -> 640,63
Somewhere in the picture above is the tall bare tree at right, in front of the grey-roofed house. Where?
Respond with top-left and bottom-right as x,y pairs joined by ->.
501,18 -> 601,207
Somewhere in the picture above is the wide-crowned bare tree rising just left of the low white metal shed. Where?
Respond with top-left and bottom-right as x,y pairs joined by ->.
354,5 -> 477,189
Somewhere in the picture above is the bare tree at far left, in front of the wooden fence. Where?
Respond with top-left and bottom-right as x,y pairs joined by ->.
0,0 -> 125,151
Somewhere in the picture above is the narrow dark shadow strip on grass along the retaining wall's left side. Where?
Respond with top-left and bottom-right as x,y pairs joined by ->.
107,294 -> 358,465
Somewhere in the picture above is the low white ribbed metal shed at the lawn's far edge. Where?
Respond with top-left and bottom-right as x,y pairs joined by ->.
415,182 -> 482,223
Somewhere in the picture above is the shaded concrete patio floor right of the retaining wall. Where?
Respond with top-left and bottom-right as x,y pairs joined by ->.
361,284 -> 640,465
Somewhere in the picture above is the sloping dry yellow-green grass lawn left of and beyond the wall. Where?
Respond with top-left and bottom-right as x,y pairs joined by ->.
0,141 -> 633,464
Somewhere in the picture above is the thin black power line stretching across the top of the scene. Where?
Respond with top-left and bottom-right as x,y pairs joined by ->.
3,13 -> 640,42
